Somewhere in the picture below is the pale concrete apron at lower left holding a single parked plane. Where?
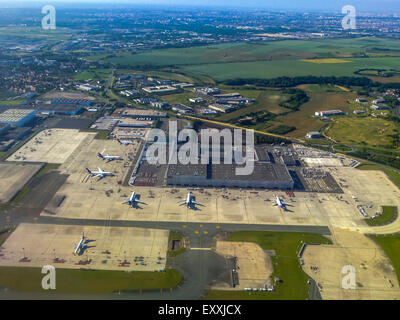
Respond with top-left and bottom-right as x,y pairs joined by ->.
0,224 -> 169,271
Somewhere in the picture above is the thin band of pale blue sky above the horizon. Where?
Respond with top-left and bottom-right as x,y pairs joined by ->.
0,0 -> 400,12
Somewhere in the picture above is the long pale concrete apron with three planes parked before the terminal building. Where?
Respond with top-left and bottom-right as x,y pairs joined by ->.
43,167 -> 400,229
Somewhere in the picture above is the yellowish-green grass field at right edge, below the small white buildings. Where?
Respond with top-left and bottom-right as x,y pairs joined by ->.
325,117 -> 398,148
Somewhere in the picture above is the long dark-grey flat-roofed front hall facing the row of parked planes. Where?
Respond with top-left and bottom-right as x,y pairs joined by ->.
167,162 -> 294,190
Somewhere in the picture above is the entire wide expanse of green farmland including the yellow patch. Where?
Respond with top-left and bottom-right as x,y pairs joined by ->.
86,38 -> 400,81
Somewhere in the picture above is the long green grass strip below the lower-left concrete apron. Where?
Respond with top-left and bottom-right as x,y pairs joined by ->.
0,267 -> 182,294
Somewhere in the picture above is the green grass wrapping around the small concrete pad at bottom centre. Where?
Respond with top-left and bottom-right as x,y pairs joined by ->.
206,231 -> 331,300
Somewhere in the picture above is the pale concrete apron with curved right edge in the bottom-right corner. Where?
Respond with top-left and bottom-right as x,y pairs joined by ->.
303,229 -> 400,300
